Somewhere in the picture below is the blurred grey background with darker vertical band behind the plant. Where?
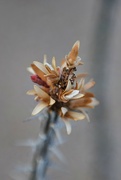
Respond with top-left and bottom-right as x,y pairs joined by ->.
0,0 -> 121,180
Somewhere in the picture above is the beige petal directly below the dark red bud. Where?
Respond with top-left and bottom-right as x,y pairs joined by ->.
34,85 -> 50,100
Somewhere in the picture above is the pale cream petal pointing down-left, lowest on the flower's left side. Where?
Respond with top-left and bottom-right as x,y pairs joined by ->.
32,101 -> 48,115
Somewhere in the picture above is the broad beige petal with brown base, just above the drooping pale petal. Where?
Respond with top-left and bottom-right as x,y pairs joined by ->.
65,111 -> 85,121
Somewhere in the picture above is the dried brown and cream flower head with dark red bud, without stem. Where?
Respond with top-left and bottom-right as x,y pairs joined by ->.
27,41 -> 98,134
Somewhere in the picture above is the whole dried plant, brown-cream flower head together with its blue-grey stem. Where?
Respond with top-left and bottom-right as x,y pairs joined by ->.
27,41 -> 98,180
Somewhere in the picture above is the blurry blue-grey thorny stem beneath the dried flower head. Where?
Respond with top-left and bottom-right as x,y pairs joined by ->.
29,111 -> 58,180
